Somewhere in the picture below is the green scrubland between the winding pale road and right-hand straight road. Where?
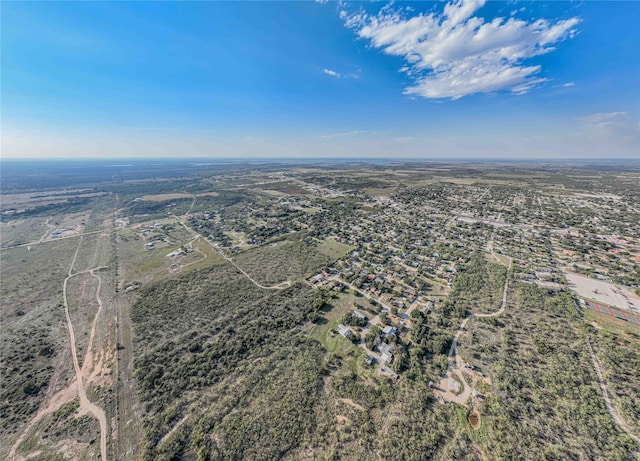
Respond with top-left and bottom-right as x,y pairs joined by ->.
460,283 -> 635,460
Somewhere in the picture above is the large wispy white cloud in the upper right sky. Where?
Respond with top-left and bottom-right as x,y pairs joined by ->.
340,0 -> 580,99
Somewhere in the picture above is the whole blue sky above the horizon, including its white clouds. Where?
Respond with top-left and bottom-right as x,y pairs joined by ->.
1,0 -> 640,159
